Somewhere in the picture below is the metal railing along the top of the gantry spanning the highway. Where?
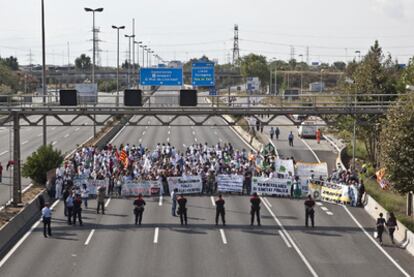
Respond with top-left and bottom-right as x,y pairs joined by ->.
0,92 -> 400,115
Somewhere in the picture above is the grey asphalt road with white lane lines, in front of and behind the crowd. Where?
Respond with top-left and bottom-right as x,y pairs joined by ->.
0,92 -> 414,277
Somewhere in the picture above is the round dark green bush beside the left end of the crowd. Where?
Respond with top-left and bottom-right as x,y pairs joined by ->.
22,144 -> 63,184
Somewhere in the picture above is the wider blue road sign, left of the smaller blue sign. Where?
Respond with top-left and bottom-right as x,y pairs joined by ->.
139,68 -> 183,86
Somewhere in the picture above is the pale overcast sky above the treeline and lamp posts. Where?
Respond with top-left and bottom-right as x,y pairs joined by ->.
0,0 -> 414,66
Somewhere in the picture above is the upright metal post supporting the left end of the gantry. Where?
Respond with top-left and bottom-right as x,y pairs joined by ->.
13,112 -> 22,207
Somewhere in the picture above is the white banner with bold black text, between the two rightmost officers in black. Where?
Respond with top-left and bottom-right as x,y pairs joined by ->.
252,177 -> 292,197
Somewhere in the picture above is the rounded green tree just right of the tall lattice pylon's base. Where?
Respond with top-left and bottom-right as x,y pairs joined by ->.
240,54 -> 270,88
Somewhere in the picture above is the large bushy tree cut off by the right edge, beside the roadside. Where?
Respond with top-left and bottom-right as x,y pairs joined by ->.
380,94 -> 414,193
